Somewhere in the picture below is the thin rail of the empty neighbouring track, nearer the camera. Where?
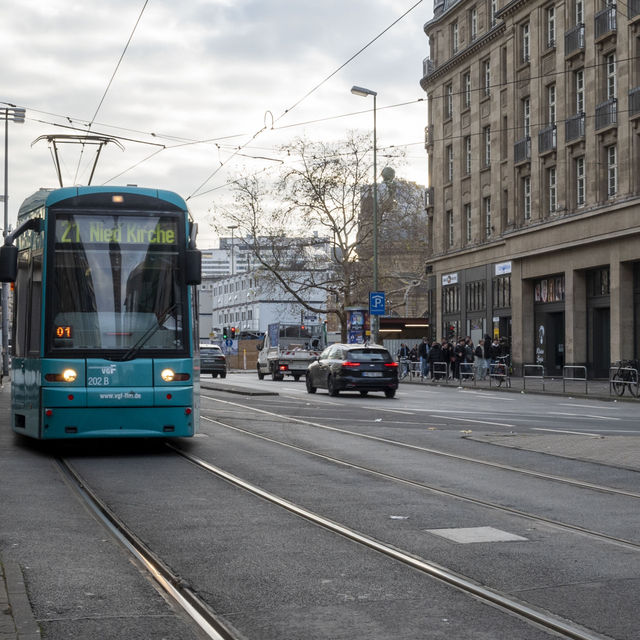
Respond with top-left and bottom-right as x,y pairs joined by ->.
196,416 -> 640,552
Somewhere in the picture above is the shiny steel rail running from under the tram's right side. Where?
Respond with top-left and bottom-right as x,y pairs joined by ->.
167,443 -> 609,640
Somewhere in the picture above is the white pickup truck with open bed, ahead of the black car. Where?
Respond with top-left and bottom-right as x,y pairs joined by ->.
256,322 -> 326,380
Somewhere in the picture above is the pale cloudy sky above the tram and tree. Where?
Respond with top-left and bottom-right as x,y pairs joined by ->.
0,0 -> 433,248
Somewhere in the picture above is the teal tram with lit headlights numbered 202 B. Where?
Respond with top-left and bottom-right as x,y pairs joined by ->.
0,187 -> 201,439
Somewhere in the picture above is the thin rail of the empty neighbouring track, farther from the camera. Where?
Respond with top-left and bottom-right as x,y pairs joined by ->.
201,395 -> 640,500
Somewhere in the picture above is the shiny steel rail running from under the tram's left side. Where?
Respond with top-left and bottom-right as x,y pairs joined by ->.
56,458 -> 239,640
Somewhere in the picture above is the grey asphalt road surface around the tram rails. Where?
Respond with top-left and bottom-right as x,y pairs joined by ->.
0,374 -> 640,640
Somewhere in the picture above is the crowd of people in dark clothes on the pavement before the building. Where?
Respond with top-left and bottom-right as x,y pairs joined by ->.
397,335 -> 509,380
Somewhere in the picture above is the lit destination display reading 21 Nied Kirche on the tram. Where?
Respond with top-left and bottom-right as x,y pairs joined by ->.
56,216 -> 178,245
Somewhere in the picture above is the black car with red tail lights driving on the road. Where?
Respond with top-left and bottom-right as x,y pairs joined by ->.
306,344 -> 398,398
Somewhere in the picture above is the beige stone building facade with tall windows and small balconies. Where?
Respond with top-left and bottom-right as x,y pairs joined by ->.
421,0 -> 640,377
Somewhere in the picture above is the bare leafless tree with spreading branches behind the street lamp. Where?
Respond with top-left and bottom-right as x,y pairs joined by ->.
214,133 -> 428,341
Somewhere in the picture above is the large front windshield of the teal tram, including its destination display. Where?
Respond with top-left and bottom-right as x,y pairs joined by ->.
47,213 -> 186,359
